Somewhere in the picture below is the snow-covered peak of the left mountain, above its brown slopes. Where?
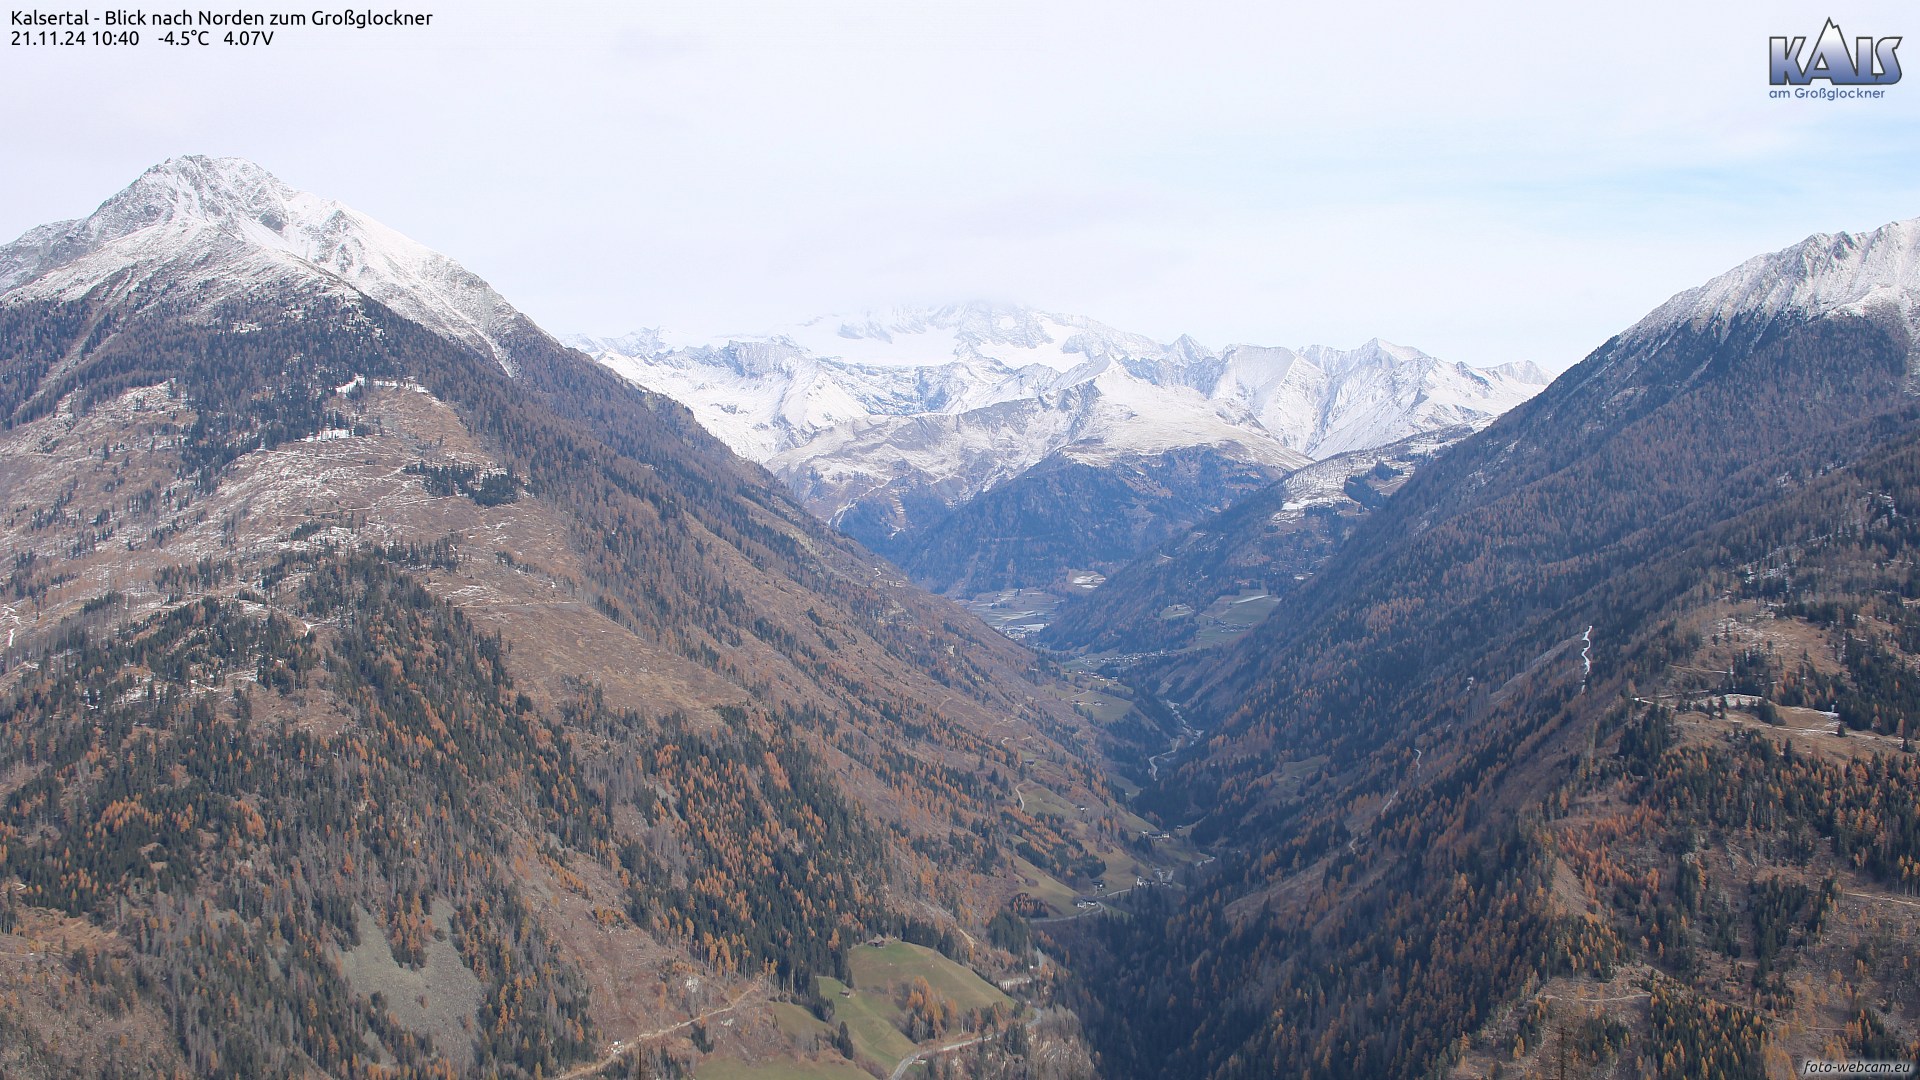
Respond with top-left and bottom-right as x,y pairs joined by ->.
0,156 -> 538,371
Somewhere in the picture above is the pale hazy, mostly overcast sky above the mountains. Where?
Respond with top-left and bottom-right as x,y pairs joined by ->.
0,0 -> 1920,369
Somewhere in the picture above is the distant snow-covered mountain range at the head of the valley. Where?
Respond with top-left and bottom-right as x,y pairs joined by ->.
568,304 -> 1548,519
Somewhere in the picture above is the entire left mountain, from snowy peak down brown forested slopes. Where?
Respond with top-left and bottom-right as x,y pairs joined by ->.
0,160 -> 1119,1076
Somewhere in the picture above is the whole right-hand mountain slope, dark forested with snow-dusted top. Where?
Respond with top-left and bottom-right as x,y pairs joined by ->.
1056,223 -> 1920,1076
